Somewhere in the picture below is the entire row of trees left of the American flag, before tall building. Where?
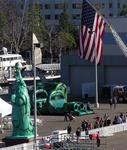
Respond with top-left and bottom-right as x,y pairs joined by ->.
0,0 -> 78,61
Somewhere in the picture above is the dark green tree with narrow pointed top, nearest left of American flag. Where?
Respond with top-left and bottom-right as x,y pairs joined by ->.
56,3 -> 77,61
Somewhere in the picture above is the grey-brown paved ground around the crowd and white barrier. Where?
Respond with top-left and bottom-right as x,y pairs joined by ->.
0,104 -> 127,150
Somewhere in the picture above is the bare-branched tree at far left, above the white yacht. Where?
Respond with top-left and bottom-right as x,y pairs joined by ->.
0,0 -> 27,53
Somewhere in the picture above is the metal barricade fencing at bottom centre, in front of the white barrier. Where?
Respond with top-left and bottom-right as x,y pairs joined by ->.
38,134 -> 107,150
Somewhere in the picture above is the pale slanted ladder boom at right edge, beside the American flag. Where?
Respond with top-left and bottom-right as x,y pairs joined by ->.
110,26 -> 127,57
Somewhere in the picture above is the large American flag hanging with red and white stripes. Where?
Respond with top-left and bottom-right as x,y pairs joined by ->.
80,0 -> 106,64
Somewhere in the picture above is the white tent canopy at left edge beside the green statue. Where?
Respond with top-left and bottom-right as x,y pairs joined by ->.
0,98 -> 12,118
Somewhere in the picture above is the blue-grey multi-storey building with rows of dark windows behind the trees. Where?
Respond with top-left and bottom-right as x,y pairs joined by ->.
34,0 -> 127,26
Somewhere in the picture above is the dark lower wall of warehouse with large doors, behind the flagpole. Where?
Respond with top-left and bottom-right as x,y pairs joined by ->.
61,55 -> 127,97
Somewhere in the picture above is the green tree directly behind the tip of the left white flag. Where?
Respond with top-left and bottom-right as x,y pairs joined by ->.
27,4 -> 50,63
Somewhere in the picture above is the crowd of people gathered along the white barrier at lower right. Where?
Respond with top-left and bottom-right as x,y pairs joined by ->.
67,113 -> 127,147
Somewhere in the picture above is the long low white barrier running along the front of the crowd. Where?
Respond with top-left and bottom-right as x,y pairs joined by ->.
0,123 -> 127,150
